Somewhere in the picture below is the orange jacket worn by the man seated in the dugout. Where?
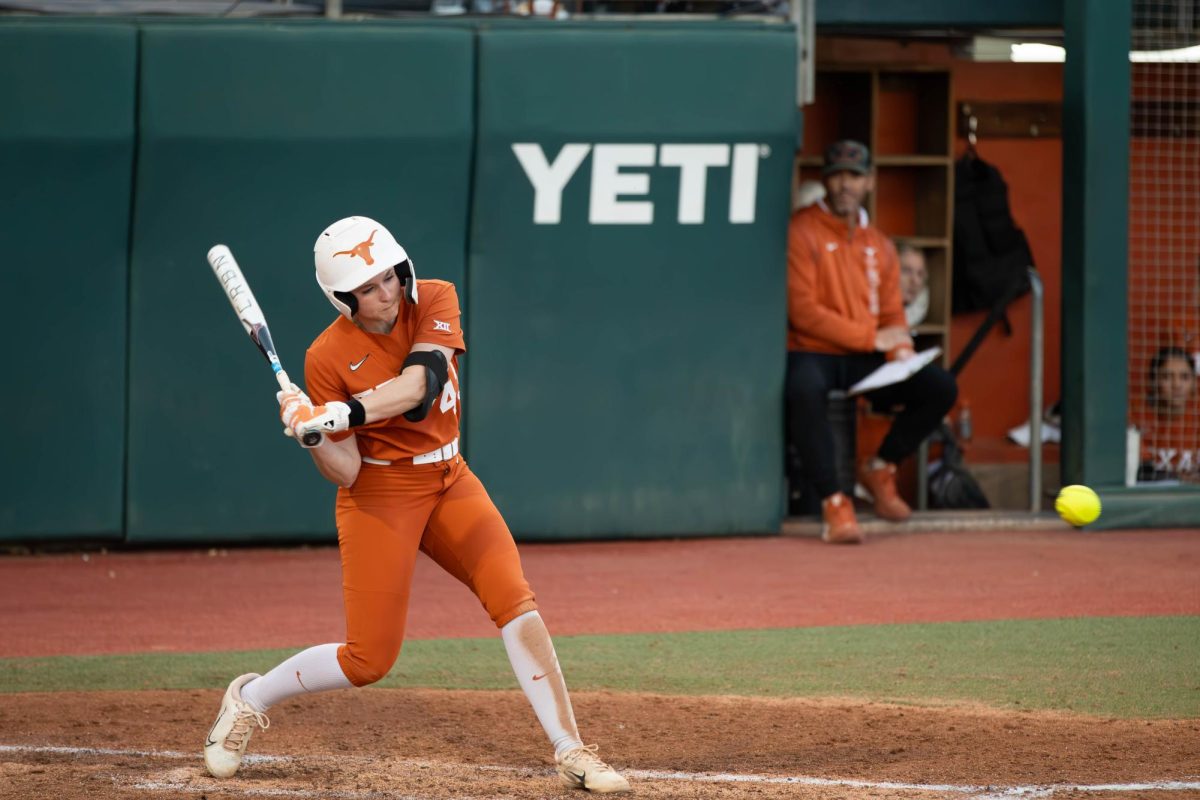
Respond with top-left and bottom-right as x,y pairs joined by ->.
787,203 -> 907,354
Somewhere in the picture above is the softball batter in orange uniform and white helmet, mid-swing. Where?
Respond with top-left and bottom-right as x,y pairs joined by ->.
204,217 -> 629,793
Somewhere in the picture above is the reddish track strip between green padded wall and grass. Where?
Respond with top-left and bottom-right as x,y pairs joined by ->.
0,530 -> 1200,657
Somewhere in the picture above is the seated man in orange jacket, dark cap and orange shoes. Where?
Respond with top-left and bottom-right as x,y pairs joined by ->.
786,139 -> 958,543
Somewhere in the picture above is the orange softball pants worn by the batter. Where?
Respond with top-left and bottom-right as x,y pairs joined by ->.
328,456 -> 538,686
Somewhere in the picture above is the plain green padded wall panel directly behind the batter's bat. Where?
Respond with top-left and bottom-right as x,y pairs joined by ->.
127,23 -> 474,541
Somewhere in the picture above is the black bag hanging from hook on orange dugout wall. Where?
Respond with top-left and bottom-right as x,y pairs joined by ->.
953,151 -> 1033,313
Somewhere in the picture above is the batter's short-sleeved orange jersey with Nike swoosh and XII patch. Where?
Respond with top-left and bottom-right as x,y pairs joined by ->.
305,281 -> 467,461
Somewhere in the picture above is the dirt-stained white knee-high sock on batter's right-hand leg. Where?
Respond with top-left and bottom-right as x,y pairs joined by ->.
500,610 -> 583,756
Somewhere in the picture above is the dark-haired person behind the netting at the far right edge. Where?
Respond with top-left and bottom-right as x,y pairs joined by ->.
1135,345 -> 1200,482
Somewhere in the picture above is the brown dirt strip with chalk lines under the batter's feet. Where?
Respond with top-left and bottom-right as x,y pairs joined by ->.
0,688 -> 1200,800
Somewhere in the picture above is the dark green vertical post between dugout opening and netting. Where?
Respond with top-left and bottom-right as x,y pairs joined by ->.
1061,0 -> 1133,488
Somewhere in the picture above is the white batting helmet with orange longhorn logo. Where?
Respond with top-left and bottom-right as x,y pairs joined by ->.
312,217 -> 416,319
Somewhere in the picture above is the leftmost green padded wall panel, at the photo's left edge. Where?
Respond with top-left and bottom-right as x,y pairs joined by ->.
0,20 -> 137,541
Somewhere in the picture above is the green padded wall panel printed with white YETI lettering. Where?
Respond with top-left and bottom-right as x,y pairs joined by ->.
464,28 -> 797,539
